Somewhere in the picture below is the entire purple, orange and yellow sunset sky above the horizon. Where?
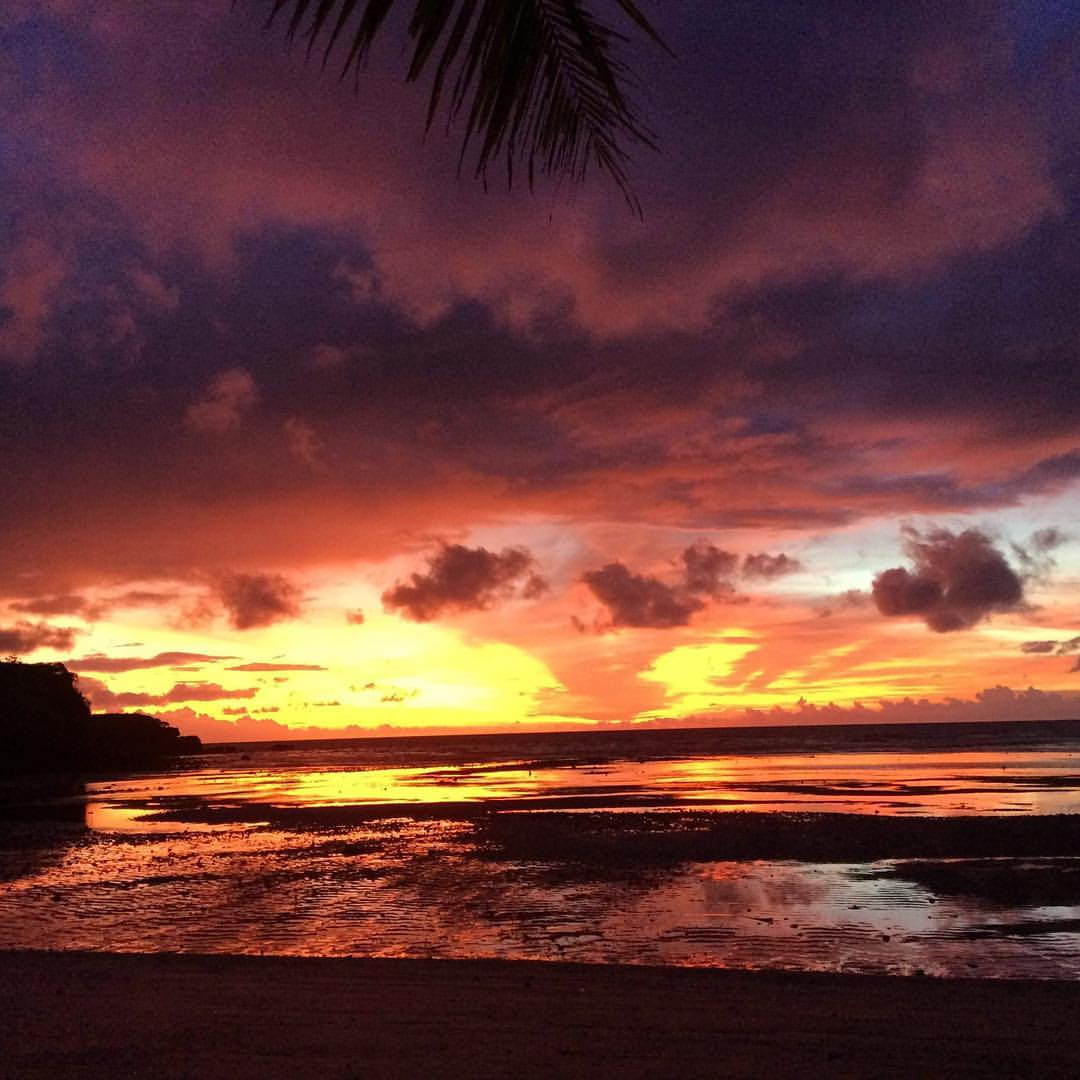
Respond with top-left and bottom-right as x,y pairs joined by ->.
0,0 -> 1080,741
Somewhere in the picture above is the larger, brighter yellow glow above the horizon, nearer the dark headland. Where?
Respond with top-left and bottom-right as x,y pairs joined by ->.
72,612 -> 565,731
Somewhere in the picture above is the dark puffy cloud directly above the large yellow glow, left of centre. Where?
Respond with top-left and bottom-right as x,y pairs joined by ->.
382,543 -> 548,622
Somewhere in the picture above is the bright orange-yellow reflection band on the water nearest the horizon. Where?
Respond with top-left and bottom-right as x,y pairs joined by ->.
86,751 -> 1080,831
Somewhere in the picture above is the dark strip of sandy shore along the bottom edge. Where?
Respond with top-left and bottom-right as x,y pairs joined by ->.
0,953 -> 1080,1080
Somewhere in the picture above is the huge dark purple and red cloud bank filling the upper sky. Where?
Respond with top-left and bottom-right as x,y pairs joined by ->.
0,0 -> 1080,600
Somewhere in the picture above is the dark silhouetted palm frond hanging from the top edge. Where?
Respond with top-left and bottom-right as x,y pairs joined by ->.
264,0 -> 662,214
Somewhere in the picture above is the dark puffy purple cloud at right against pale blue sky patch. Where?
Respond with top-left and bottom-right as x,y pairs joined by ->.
873,528 -> 1024,634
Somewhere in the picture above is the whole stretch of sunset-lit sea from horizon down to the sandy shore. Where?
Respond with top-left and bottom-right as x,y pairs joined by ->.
0,721 -> 1080,980
